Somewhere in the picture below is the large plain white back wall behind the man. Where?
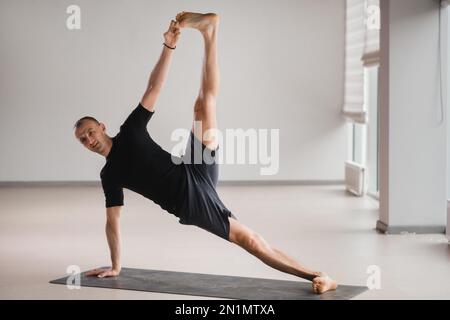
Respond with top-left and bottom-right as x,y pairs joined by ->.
0,0 -> 347,181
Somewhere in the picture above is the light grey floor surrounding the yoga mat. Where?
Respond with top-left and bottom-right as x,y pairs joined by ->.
0,185 -> 450,299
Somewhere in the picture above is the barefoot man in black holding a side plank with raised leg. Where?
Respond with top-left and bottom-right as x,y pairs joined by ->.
75,11 -> 337,293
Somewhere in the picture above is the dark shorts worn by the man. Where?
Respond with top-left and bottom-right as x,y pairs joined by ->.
179,130 -> 236,241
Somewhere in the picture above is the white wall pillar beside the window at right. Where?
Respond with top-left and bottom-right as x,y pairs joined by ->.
380,0 -> 447,232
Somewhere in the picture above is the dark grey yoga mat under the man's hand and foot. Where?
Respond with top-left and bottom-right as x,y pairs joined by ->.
50,268 -> 367,300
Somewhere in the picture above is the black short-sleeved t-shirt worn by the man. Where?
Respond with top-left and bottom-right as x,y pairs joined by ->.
100,103 -> 186,216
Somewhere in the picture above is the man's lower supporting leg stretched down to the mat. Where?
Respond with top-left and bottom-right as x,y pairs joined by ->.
228,218 -> 337,293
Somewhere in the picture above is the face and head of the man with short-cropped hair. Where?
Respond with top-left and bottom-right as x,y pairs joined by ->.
75,120 -> 107,154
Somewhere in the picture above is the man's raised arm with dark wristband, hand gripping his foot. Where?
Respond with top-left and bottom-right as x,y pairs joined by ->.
141,20 -> 180,112
